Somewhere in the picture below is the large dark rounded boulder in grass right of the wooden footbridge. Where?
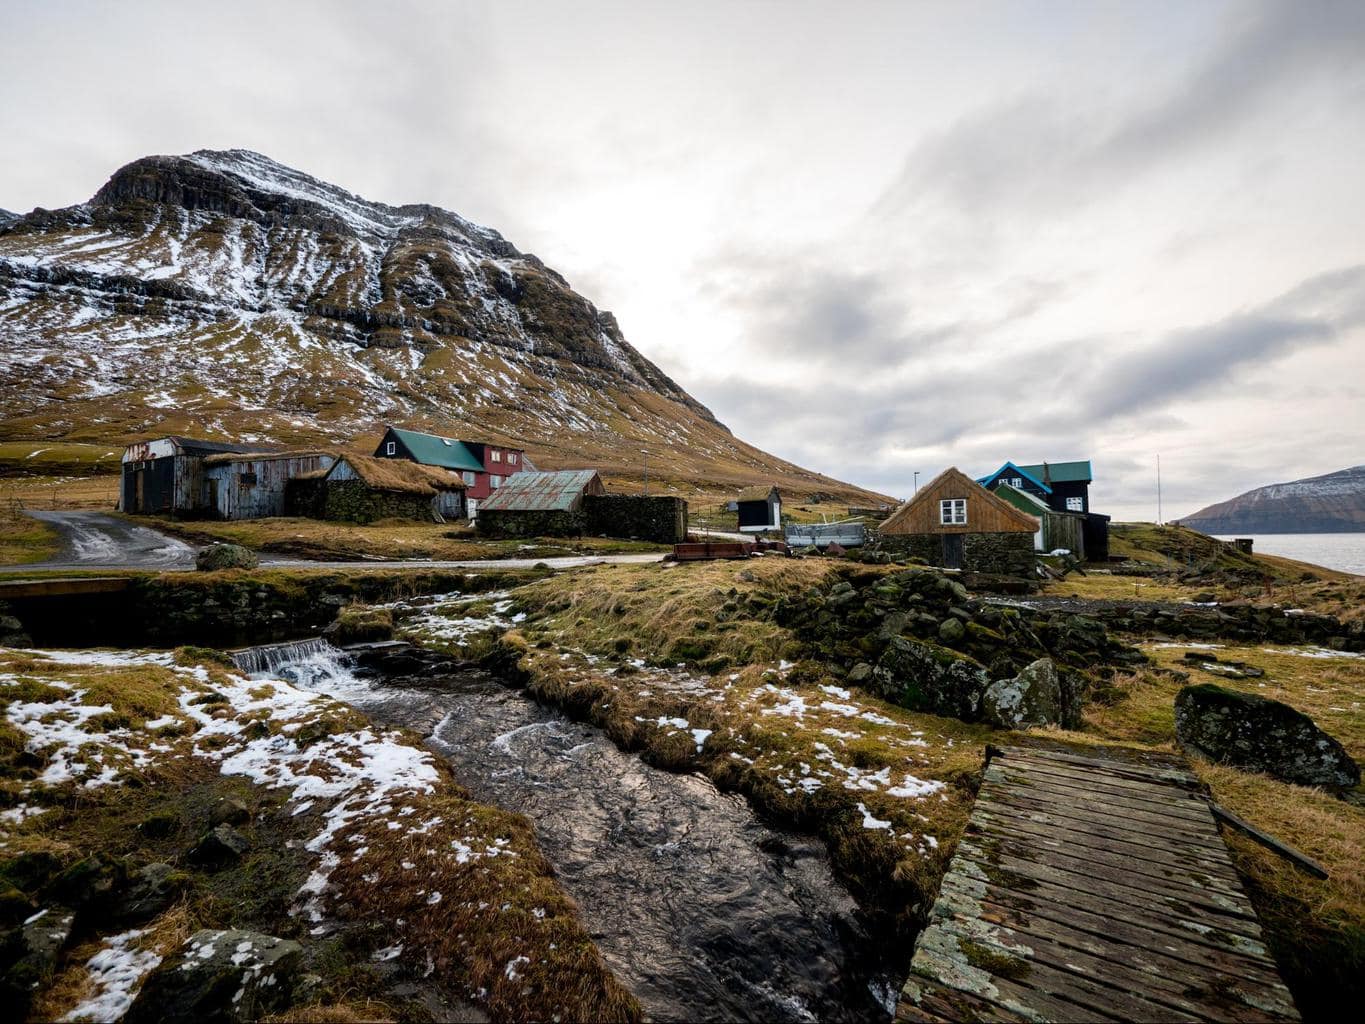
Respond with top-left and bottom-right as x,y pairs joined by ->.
1175,683 -> 1361,789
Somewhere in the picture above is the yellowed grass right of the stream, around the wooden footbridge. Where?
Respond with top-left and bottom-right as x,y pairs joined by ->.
390,558 -> 1365,1017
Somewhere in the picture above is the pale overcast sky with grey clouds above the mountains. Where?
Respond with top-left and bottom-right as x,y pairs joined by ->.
0,0 -> 1365,519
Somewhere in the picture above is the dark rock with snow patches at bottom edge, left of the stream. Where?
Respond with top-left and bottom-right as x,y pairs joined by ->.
124,930 -> 303,1024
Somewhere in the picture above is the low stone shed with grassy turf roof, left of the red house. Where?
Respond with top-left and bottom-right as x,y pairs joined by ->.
296,455 -> 464,523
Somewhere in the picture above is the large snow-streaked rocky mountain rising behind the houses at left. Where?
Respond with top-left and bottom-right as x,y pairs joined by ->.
0,150 -> 868,490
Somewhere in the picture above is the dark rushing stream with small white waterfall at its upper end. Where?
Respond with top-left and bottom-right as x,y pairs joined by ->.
244,642 -> 904,1021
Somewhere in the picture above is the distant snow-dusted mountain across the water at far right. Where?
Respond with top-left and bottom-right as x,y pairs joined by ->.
1181,466 -> 1365,535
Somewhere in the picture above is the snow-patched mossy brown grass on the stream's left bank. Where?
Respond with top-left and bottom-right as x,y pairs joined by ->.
0,650 -> 640,1021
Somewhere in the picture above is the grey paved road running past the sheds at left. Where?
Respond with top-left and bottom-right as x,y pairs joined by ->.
16,512 -> 663,571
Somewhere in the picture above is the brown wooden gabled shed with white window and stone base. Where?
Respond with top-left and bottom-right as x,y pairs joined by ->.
878,467 -> 1040,575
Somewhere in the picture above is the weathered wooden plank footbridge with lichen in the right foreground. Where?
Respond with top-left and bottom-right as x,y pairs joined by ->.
895,747 -> 1299,1023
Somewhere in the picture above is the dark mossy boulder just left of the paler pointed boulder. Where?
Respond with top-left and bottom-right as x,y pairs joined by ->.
864,636 -> 990,722
